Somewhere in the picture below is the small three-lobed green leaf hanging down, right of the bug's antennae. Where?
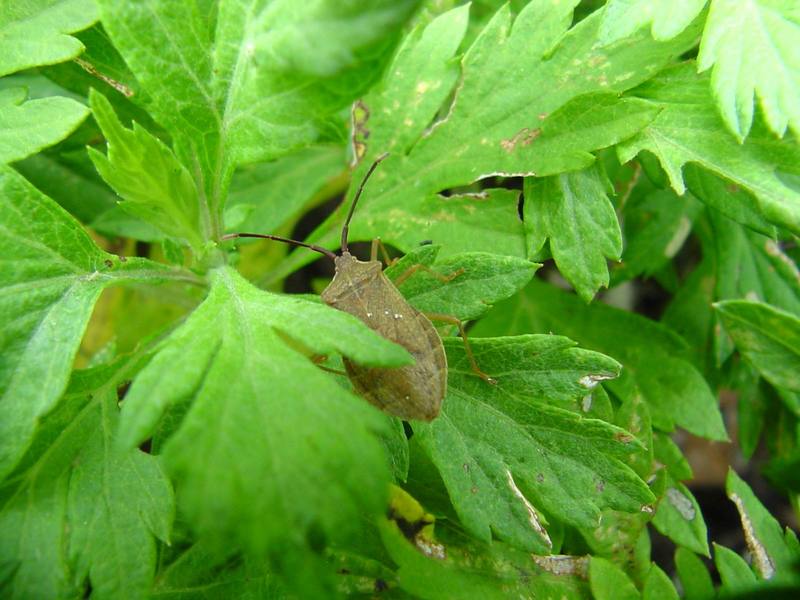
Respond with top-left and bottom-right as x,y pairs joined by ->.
524,168 -> 622,302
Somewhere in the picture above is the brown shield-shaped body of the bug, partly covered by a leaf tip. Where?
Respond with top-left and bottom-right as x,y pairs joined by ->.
322,252 -> 447,421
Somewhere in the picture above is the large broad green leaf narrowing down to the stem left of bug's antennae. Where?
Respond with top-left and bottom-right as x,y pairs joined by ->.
99,0 -> 415,237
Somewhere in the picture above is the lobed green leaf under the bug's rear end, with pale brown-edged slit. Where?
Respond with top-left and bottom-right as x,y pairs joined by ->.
413,336 -> 653,551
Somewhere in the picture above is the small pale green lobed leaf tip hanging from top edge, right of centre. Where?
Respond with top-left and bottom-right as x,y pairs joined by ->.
600,0 -> 706,43
